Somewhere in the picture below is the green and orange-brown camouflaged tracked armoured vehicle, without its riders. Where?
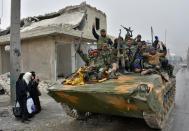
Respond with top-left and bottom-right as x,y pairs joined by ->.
49,74 -> 176,129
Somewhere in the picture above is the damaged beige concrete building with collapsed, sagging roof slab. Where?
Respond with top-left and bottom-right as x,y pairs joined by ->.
0,3 -> 107,80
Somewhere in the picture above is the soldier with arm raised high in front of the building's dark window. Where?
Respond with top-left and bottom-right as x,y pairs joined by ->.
92,24 -> 113,49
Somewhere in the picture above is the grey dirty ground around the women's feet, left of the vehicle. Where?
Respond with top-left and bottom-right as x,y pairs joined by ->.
0,90 -> 73,131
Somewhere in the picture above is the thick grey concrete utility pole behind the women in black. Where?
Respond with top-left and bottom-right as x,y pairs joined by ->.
10,0 -> 21,104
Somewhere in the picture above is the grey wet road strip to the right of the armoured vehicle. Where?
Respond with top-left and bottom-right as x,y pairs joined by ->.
170,69 -> 189,131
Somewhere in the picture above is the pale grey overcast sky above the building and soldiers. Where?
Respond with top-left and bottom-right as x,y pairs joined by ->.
0,0 -> 189,56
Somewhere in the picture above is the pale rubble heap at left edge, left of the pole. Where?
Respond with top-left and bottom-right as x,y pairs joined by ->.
0,73 -> 10,95
